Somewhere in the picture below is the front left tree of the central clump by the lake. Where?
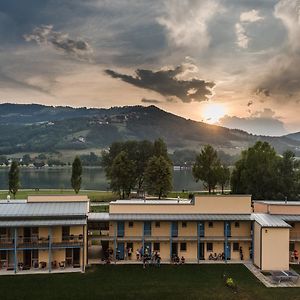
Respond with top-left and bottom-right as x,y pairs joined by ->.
107,151 -> 136,199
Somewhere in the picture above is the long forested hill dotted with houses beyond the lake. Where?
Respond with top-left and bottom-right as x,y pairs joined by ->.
0,104 -> 300,155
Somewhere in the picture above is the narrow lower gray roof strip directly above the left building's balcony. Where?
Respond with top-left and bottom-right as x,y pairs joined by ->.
0,219 -> 87,227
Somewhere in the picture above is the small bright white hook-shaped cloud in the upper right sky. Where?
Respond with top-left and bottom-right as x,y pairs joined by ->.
235,9 -> 264,49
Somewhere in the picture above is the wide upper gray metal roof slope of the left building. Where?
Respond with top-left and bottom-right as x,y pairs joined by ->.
0,200 -> 88,218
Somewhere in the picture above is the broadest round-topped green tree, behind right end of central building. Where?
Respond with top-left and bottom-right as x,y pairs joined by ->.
231,141 -> 280,199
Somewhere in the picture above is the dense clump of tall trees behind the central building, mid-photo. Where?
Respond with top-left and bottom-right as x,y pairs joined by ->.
102,139 -> 172,199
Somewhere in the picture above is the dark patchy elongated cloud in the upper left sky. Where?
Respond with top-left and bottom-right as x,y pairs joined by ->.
24,25 -> 93,59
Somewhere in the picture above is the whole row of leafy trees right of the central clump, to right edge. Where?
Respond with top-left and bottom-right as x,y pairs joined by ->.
193,142 -> 300,200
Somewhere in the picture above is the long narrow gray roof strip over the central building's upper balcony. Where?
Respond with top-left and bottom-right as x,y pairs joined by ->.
88,213 -> 251,221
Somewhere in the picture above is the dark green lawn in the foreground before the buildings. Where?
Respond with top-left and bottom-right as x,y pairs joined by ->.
0,265 -> 300,300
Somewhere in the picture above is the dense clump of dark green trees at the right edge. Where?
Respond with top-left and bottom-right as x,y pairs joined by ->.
231,142 -> 300,200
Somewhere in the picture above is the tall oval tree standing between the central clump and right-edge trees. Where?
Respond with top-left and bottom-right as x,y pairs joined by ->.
193,145 -> 220,194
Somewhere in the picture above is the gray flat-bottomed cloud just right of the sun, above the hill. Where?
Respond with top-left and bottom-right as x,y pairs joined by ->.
220,108 -> 287,136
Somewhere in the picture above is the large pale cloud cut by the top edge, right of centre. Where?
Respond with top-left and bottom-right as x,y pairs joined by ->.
157,0 -> 223,51
